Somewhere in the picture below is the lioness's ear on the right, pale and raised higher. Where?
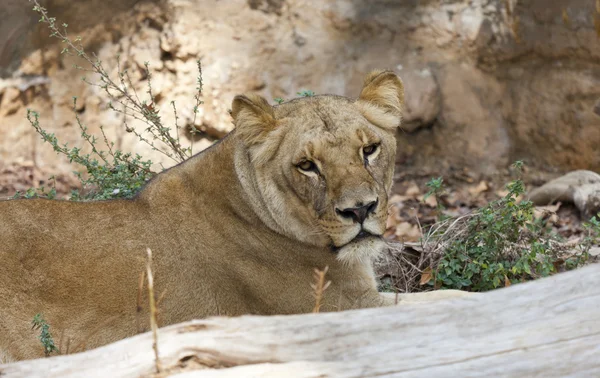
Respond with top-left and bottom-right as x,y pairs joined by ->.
356,71 -> 404,129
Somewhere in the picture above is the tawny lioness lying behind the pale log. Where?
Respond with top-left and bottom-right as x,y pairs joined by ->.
0,71 -> 464,360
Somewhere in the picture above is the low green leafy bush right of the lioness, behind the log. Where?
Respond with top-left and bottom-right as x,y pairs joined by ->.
425,162 -> 595,291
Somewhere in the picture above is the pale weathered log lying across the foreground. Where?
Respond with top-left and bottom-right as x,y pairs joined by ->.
0,264 -> 600,378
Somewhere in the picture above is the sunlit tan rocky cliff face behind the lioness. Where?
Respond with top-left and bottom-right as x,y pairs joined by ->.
0,0 -> 600,192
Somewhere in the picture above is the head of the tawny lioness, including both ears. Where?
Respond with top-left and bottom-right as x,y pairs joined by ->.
232,71 -> 404,262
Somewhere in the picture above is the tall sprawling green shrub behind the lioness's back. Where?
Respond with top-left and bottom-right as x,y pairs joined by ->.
15,0 -> 203,200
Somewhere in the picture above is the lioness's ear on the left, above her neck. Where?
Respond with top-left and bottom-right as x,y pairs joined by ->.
231,94 -> 276,146
